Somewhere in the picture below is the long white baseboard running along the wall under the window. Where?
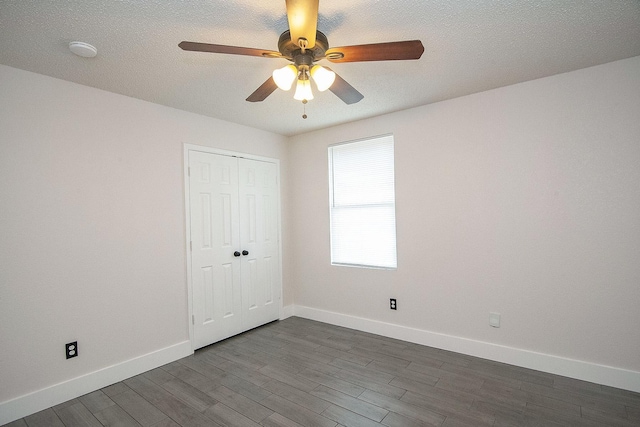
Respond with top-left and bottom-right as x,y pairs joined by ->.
293,305 -> 640,392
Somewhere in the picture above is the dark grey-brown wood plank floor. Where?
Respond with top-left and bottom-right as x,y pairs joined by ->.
8,317 -> 640,427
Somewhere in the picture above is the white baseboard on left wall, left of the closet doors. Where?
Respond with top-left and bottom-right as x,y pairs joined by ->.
0,341 -> 193,425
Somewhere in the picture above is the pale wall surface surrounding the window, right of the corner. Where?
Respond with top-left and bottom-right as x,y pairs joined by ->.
290,57 -> 640,391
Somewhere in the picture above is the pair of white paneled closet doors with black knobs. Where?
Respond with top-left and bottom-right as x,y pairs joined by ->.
188,150 -> 281,349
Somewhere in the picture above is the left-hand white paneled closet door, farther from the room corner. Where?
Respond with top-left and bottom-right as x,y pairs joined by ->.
189,151 -> 243,348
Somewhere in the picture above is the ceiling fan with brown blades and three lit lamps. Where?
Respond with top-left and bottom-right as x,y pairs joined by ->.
178,0 -> 424,106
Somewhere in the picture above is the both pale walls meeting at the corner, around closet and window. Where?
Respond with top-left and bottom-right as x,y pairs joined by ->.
0,52 -> 640,420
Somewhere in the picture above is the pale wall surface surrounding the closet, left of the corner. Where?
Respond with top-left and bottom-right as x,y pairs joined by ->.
0,66 -> 292,412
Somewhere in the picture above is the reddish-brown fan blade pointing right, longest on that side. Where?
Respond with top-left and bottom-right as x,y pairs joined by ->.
325,40 -> 424,62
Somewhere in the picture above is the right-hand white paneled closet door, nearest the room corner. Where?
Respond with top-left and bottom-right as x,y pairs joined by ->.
238,159 -> 280,330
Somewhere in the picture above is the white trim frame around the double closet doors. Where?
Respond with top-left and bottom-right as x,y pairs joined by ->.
183,143 -> 283,352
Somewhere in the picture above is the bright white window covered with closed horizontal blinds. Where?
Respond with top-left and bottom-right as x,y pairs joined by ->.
329,135 -> 397,269
